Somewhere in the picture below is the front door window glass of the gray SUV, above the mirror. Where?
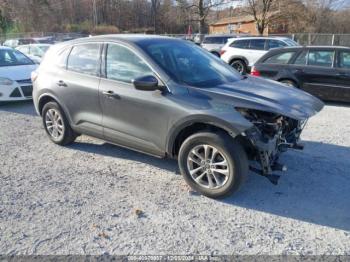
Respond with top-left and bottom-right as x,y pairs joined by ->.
106,44 -> 153,83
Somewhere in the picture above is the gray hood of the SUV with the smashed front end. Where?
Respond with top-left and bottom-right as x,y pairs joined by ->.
192,76 -> 324,120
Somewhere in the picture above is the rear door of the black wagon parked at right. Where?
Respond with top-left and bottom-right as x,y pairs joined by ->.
294,48 -> 338,100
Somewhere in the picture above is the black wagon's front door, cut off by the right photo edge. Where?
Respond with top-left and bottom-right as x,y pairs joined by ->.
334,49 -> 350,102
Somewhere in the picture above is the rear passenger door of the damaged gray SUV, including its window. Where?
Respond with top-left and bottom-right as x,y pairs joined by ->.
53,43 -> 102,137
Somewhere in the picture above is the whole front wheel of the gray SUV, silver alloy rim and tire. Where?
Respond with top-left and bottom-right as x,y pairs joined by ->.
178,132 -> 248,198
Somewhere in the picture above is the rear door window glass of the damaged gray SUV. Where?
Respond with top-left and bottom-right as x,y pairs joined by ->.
67,44 -> 100,76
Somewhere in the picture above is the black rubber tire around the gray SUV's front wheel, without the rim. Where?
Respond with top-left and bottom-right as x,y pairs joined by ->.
178,132 -> 249,198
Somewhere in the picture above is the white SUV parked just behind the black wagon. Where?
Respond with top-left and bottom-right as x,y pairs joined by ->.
220,37 -> 298,74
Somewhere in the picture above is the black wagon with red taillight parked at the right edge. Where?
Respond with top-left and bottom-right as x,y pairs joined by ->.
251,46 -> 350,102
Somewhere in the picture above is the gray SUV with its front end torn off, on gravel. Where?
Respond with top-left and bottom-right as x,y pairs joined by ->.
32,35 -> 323,198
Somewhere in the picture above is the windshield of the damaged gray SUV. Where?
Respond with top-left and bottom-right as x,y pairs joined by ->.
139,40 -> 242,87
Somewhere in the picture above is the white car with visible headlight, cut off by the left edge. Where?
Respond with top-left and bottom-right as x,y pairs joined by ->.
0,46 -> 37,102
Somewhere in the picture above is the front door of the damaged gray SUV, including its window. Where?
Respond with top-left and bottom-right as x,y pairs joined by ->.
100,44 -> 171,156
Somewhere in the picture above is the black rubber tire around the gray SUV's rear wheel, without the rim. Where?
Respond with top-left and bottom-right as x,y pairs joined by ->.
41,102 -> 77,146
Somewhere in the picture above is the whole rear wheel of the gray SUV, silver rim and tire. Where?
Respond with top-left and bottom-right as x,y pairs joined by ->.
42,102 -> 77,145
